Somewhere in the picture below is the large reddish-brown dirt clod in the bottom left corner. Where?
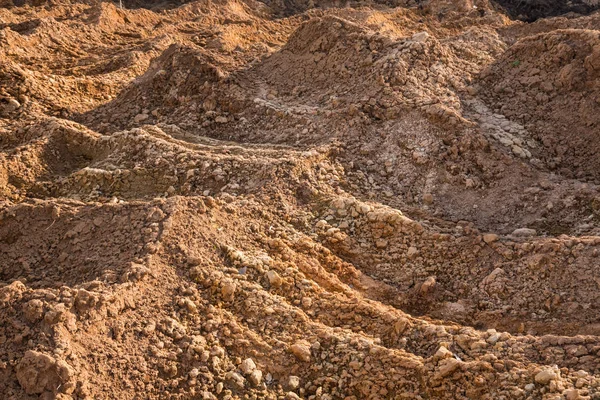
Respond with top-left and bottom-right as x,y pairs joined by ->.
16,350 -> 73,394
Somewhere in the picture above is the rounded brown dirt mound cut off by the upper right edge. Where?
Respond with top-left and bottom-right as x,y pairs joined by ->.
481,30 -> 600,183
